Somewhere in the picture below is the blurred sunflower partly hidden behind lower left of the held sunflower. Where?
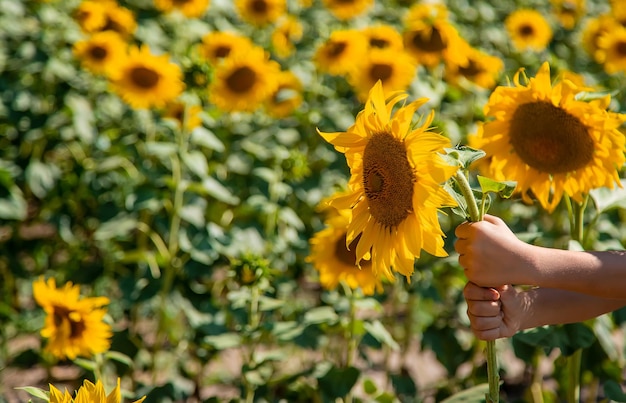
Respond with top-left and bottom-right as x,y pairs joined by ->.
307,208 -> 383,295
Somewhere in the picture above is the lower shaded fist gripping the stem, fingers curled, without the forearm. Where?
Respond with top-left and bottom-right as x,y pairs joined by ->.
463,282 -> 526,340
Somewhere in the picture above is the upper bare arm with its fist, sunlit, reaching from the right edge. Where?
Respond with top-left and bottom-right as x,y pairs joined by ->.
455,215 -> 626,299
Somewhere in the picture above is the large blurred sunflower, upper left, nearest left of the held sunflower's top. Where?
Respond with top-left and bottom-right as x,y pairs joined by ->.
209,48 -> 280,112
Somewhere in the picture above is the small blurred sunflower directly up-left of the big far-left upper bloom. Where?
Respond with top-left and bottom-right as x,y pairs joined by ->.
73,31 -> 128,75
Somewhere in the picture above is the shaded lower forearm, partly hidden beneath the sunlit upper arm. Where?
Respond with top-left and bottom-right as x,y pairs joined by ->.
519,288 -> 626,330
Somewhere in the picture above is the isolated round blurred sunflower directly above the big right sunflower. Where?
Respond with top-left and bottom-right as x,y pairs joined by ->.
504,9 -> 552,52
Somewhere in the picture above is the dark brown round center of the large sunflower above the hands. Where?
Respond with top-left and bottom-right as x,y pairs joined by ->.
510,102 -> 594,174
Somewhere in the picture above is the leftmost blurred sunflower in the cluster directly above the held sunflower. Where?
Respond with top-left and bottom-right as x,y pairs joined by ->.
313,29 -> 367,76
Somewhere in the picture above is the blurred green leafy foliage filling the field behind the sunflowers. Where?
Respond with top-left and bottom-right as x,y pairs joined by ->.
0,0 -> 626,402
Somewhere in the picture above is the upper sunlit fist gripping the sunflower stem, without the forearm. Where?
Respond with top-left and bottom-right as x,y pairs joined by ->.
454,215 -> 535,287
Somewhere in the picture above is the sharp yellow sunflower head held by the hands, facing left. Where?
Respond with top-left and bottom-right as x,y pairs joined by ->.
318,82 -> 456,281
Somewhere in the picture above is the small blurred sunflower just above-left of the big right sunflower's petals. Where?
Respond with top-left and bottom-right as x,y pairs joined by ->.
446,48 -> 504,89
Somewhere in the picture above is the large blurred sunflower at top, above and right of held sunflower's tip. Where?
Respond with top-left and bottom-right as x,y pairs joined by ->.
402,3 -> 469,67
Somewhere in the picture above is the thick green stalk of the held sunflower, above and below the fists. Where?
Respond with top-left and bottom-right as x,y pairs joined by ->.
454,169 -> 500,403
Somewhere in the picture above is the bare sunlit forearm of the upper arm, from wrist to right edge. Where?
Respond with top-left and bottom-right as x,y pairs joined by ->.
525,247 -> 626,299
